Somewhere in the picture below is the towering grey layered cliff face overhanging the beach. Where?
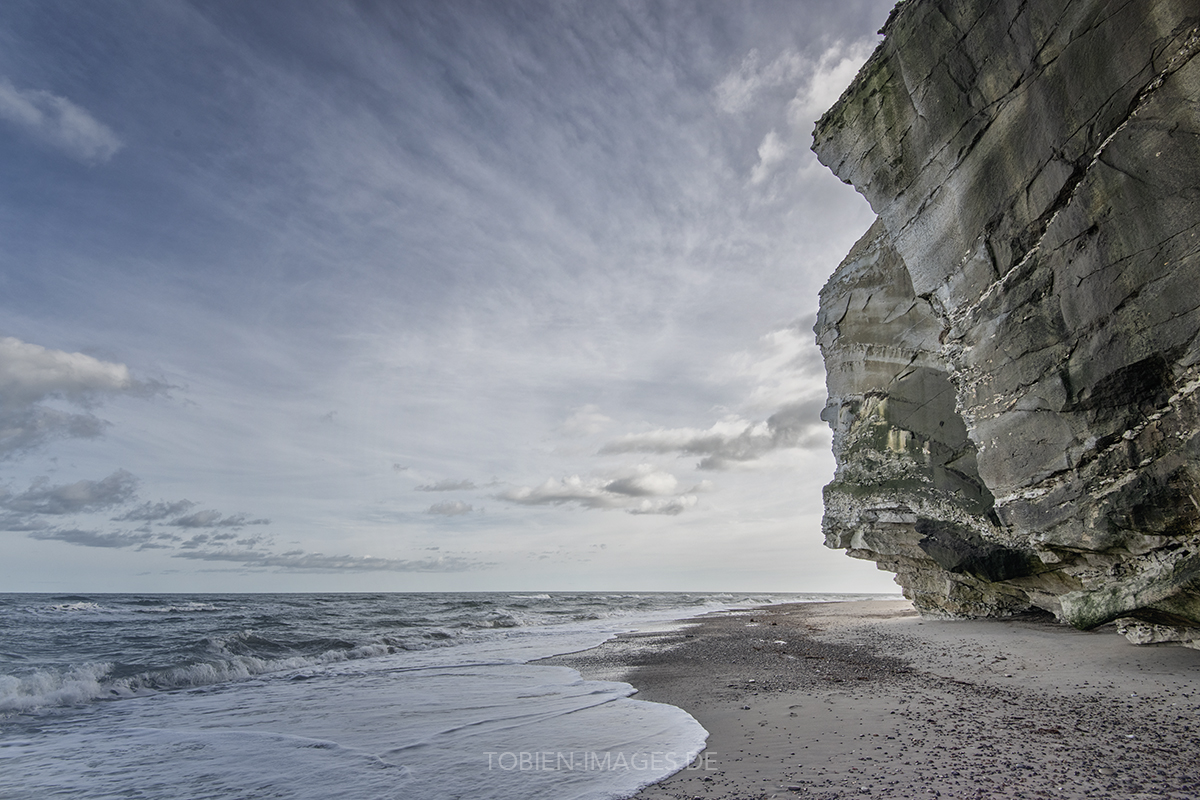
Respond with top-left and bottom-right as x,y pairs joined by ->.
814,0 -> 1200,644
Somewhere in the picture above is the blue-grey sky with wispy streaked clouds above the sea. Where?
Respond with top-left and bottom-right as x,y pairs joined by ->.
0,0 -> 896,591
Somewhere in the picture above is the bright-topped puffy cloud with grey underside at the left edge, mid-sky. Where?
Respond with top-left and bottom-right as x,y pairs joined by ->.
0,336 -> 147,458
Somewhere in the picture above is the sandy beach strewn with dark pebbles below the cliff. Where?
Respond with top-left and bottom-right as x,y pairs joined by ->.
551,601 -> 1200,800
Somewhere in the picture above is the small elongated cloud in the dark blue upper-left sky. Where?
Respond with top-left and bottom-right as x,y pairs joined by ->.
0,78 -> 122,164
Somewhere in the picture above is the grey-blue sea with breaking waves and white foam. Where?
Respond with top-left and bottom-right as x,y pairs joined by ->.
0,593 -> 883,800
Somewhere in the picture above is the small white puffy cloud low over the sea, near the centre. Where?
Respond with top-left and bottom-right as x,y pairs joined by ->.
497,464 -> 696,513
